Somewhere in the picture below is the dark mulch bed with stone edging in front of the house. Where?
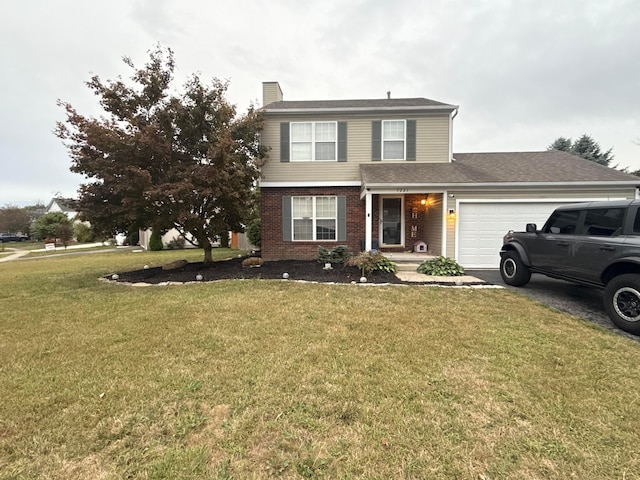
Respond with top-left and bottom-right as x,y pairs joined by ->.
105,258 -> 405,284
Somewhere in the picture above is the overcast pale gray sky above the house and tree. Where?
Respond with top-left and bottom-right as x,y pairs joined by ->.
0,0 -> 640,206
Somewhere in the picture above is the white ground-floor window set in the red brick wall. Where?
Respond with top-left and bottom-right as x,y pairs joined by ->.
291,196 -> 338,241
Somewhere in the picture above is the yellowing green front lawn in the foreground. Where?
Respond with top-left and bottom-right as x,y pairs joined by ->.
0,249 -> 640,479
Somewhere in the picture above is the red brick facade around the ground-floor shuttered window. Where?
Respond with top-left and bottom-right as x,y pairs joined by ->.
260,187 -> 365,260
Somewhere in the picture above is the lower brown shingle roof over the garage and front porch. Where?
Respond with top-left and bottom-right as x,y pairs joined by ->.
360,150 -> 640,186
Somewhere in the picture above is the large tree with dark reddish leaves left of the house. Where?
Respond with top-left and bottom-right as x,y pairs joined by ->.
56,47 -> 266,262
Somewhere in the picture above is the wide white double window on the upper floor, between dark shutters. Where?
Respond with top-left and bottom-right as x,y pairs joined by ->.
290,122 -> 338,161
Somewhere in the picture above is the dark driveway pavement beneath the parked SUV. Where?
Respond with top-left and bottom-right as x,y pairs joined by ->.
465,269 -> 640,341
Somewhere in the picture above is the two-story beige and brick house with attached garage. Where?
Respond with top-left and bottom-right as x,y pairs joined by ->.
260,82 -> 640,268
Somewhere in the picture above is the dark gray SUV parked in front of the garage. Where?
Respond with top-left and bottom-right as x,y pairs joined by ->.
500,200 -> 640,335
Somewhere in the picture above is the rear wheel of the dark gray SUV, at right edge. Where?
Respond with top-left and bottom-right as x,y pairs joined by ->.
604,273 -> 640,335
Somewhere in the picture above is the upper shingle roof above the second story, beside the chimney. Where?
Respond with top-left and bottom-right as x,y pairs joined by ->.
263,98 -> 458,113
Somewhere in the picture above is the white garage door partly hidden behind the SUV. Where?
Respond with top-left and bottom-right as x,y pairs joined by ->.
458,201 -> 571,268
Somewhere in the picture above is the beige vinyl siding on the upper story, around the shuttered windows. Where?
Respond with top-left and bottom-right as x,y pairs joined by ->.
262,114 -> 450,182
